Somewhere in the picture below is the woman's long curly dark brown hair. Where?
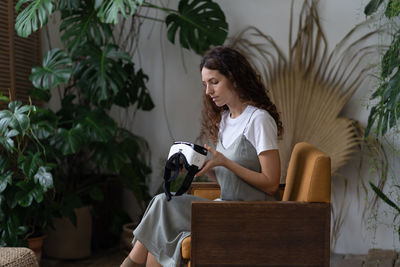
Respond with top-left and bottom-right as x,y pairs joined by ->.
200,46 -> 283,146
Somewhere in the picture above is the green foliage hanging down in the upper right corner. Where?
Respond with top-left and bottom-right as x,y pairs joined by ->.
364,0 -> 400,136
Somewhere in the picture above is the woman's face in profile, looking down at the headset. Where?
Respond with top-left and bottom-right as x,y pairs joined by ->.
201,67 -> 237,107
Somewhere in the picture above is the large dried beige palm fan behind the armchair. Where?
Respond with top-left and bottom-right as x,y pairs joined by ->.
230,1 -> 377,182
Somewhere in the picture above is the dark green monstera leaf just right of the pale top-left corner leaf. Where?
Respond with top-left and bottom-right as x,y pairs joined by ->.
60,2 -> 112,56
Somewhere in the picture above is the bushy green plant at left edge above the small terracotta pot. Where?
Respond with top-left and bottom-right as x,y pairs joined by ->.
0,96 -> 54,264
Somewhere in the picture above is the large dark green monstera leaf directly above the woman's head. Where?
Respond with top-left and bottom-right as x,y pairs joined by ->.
165,0 -> 228,54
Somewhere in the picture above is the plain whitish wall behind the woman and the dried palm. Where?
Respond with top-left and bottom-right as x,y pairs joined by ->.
126,0 -> 399,254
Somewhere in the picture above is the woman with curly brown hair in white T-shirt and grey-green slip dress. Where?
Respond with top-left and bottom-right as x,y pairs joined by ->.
121,47 -> 283,267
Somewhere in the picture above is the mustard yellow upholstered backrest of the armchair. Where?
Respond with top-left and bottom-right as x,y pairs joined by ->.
282,142 -> 331,202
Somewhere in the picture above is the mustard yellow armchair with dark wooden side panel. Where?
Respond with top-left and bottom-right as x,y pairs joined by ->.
182,142 -> 331,267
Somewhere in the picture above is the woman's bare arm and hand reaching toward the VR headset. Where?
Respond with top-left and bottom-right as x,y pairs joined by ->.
196,145 -> 281,195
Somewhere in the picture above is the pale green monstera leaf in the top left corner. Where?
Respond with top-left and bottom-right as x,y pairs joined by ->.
15,0 -> 54,37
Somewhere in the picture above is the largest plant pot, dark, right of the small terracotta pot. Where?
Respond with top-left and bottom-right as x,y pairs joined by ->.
44,206 -> 92,259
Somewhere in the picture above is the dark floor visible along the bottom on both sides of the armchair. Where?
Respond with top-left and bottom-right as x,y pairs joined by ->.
40,248 -> 400,267
